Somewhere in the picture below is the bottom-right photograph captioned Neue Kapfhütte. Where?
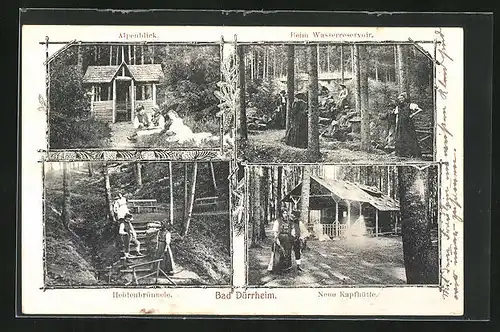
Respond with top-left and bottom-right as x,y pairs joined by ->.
245,164 -> 440,288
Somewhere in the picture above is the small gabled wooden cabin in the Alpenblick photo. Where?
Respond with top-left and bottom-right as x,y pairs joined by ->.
83,62 -> 163,123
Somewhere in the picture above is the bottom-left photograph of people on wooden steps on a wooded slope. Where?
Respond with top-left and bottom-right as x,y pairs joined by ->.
44,162 -> 232,288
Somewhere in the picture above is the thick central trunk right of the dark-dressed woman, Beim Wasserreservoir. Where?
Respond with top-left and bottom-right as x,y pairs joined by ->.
307,45 -> 320,161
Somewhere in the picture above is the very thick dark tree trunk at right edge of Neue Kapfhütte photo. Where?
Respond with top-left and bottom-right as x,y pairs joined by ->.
398,166 -> 438,284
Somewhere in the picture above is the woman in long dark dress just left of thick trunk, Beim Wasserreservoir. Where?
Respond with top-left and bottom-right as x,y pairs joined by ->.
285,93 -> 309,149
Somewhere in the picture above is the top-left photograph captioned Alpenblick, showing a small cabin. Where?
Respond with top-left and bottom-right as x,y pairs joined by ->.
46,41 -> 230,149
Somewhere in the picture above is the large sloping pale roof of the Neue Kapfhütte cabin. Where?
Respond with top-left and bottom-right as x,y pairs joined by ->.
283,176 -> 399,211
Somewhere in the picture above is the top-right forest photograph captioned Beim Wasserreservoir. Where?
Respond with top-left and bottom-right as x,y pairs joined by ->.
236,40 -> 436,164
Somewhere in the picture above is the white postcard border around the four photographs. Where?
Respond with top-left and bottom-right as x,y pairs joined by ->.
21,26 -> 463,315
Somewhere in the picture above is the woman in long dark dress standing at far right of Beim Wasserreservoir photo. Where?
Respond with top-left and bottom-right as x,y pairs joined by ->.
394,92 -> 422,158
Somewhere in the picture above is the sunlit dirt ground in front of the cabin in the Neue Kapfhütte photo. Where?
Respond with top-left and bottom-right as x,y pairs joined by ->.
248,224 -> 406,287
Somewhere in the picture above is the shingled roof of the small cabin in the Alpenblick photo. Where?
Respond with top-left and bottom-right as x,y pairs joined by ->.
83,63 -> 163,83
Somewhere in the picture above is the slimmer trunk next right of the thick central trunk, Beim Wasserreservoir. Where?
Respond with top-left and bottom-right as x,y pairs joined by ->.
357,45 -> 371,151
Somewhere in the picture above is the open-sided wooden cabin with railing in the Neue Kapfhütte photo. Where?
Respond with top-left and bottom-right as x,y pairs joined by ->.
282,176 -> 399,237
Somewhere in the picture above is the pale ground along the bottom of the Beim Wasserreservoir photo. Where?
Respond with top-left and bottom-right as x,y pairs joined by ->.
240,130 -> 422,163
